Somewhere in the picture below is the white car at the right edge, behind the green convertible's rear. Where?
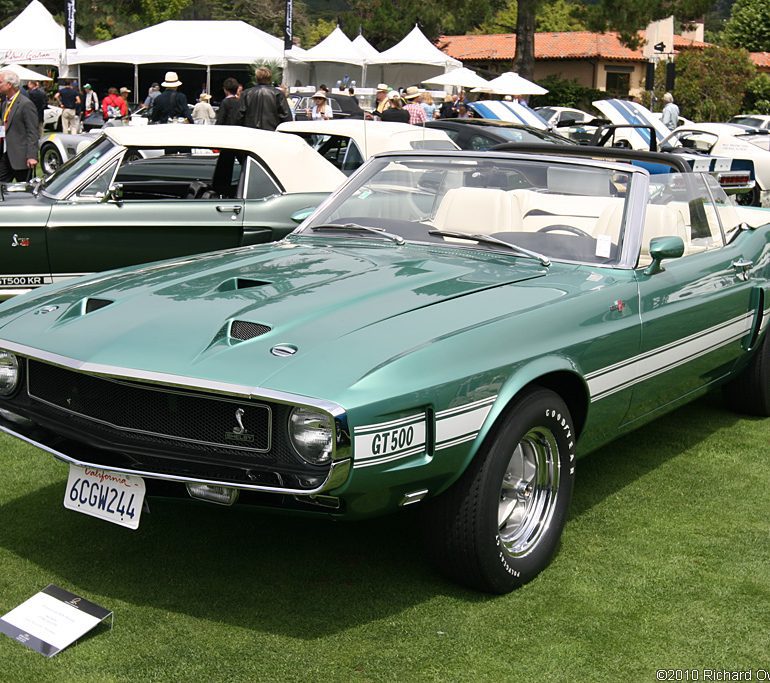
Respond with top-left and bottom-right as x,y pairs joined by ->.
662,123 -> 770,207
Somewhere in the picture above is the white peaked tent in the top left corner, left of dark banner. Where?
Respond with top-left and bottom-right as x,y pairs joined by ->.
0,0 -> 88,68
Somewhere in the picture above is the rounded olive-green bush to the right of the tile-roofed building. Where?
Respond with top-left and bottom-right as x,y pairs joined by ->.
673,47 -> 756,121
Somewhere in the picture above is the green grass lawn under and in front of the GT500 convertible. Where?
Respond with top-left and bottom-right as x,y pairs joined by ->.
0,397 -> 770,683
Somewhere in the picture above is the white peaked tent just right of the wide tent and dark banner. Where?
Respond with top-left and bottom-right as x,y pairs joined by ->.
287,26 -> 365,85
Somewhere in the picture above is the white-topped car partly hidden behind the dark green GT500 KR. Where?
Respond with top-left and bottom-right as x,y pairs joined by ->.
277,119 -> 459,175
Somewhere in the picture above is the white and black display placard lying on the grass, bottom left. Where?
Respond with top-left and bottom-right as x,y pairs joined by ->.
0,583 -> 112,657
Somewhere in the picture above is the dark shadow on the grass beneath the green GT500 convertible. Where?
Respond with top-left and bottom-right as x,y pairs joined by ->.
0,398 -> 752,639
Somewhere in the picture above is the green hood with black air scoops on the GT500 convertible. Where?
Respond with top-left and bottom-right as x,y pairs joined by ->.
0,240 -> 547,400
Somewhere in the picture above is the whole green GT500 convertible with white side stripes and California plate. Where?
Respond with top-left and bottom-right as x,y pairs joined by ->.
0,143 -> 770,593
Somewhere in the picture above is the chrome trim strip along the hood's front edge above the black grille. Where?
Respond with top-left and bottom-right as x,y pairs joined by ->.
0,339 -> 345,418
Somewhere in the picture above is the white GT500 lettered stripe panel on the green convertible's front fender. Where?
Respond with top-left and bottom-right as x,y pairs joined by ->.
353,413 -> 426,467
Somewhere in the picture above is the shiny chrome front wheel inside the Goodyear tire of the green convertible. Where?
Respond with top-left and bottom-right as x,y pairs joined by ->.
497,427 -> 560,557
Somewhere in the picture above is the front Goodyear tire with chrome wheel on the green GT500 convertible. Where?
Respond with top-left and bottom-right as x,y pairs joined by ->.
425,388 -> 575,594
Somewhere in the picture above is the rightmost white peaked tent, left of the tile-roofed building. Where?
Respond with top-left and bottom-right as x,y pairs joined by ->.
367,26 -> 462,86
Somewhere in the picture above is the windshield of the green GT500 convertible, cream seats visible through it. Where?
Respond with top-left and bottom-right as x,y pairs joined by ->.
296,156 -> 635,264
